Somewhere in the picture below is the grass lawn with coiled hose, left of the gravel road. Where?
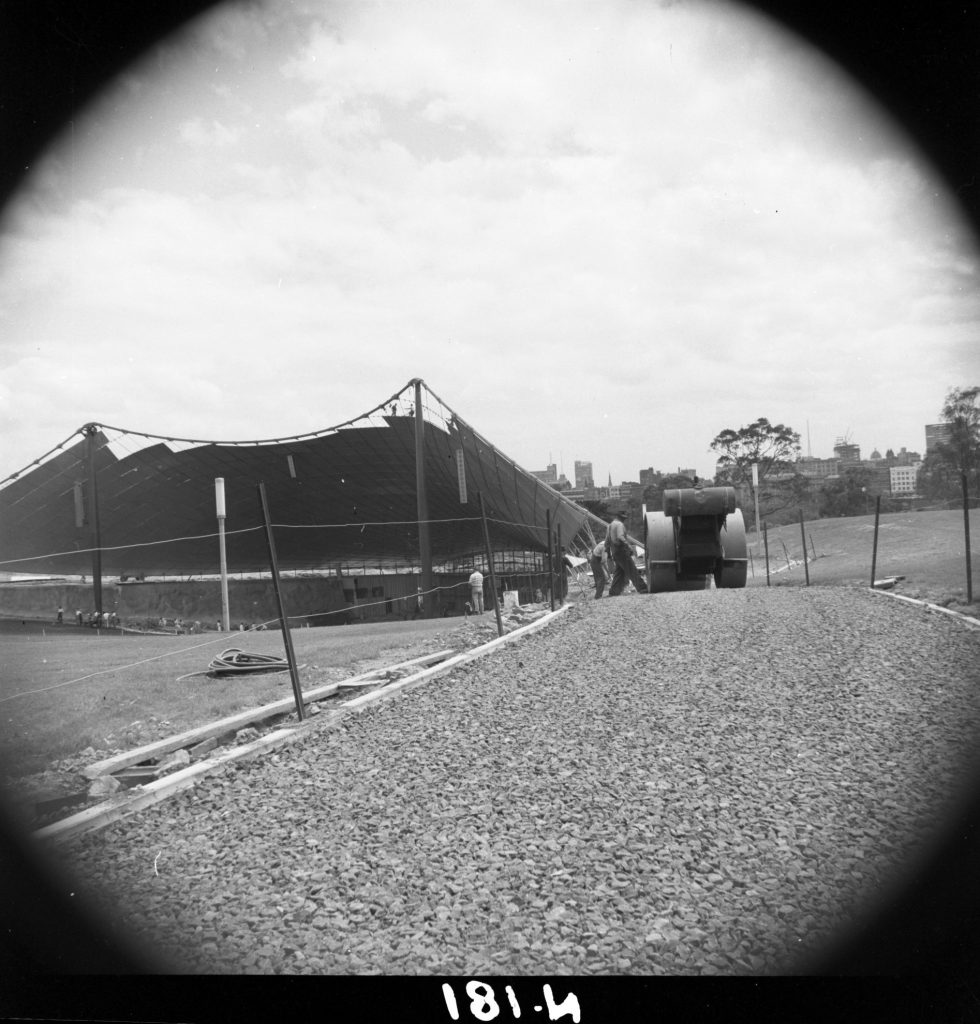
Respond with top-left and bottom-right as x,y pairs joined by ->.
0,615 -> 487,779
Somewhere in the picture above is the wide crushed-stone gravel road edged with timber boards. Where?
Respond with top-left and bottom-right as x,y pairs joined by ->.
45,588 -> 980,977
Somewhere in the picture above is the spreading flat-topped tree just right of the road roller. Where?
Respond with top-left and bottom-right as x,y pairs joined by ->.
711,417 -> 806,515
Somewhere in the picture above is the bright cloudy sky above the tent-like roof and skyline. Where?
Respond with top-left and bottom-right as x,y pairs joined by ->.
0,0 -> 980,482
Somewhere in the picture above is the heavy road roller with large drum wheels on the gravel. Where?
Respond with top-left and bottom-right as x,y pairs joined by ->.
643,487 -> 749,594
